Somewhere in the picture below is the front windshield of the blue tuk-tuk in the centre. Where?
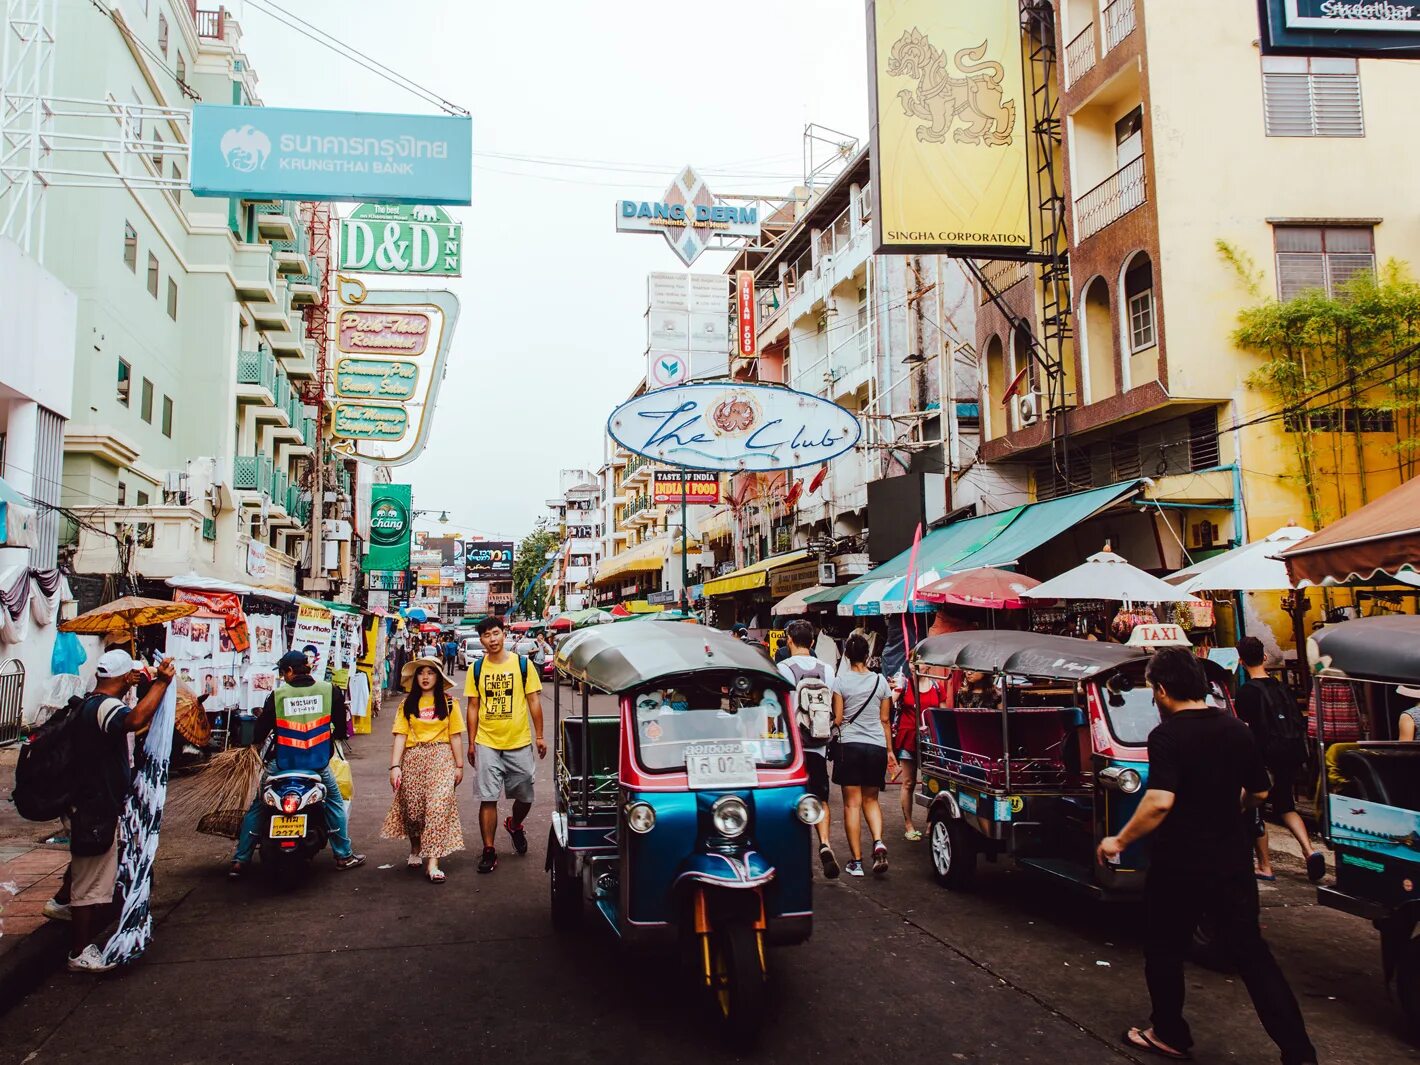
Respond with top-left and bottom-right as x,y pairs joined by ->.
632,680 -> 794,772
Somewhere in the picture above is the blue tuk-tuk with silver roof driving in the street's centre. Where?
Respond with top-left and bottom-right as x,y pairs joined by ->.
547,625 -> 824,1037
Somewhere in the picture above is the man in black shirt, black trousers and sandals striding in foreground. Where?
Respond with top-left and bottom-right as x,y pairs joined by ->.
1096,648 -> 1316,1065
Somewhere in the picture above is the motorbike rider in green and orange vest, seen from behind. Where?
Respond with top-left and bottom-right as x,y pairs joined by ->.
227,650 -> 365,880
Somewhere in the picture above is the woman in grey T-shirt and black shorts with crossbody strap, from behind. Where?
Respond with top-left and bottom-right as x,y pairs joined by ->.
834,636 -> 897,876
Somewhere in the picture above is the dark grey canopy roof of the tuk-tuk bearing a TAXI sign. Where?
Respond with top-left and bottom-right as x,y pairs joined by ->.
912,630 -> 1149,680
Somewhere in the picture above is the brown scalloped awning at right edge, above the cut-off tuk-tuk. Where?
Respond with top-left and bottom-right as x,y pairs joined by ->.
1277,477 -> 1420,585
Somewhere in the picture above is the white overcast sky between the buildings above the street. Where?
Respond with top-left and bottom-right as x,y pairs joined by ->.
232,0 -> 868,537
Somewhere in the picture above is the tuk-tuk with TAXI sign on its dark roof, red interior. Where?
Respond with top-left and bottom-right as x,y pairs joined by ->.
910,632 -> 1231,899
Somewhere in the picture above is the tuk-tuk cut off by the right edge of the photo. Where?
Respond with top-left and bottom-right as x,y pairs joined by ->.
1308,615 -> 1420,1035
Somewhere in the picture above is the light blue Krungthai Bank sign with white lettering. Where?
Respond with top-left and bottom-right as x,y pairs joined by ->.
192,104 -> 473,204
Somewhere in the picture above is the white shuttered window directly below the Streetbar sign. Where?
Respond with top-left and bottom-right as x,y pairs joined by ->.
1262,55 -> 1366,136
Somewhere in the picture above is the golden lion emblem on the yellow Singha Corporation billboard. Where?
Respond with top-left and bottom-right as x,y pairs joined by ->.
888,30 -> 1015,146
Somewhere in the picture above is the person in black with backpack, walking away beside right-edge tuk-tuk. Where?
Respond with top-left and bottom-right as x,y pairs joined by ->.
1237,636 -> 1326,880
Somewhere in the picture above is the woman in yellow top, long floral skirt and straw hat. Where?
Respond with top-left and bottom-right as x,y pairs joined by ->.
379,657 -> 469,883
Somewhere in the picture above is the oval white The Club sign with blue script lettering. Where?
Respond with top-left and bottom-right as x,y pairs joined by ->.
606,383 -> 862,471
